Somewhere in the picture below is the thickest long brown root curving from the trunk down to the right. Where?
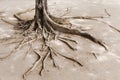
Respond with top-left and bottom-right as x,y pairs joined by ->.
43,1 -> 108,50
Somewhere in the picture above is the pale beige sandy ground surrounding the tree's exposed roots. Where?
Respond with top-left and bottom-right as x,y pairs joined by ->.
0,0 -> 120,80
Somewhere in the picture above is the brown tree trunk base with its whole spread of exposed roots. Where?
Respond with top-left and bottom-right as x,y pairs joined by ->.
0,0 -> 120,80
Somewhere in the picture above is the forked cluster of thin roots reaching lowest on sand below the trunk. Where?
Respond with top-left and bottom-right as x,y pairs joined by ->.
23,41 -> 83,80
